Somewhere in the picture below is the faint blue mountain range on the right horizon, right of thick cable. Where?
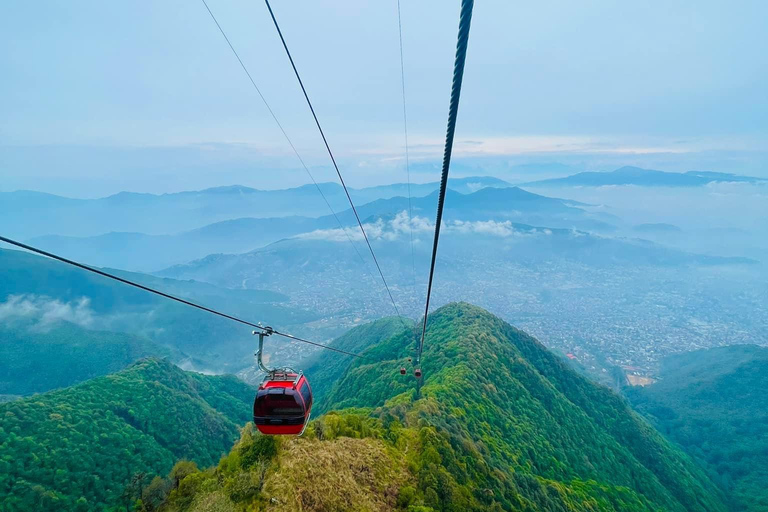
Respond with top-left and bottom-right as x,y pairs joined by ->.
520,166 -> 768,187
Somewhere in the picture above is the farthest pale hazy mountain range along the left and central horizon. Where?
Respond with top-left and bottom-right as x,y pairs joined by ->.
0,177 -> 510,239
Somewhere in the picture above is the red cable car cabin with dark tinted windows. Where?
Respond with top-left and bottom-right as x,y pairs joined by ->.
253,373 -> 312,435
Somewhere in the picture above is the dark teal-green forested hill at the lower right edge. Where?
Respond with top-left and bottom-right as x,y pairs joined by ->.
628,345 -> 768,512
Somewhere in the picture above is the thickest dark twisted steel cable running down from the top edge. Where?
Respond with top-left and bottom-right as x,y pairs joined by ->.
416,0 -> 474,370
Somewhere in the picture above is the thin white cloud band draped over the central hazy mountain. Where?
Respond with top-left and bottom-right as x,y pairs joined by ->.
296,210 -> 552,243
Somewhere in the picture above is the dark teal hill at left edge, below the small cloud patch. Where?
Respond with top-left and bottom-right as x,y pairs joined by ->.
0,321 -> 170,395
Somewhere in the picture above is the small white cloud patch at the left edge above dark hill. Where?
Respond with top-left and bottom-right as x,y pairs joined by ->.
0,295 -> 94,328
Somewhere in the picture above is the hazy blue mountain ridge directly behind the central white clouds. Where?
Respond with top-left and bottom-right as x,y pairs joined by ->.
21,185 -> 615,272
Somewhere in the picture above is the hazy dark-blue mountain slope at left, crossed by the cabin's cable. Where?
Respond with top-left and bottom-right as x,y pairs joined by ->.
0,249 -> 317,372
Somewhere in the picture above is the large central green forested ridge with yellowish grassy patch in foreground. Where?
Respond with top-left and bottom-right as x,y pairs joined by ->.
148,304 -> 726,512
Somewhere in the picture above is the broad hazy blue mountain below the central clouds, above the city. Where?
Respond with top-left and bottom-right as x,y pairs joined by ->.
157,219 -> 754,295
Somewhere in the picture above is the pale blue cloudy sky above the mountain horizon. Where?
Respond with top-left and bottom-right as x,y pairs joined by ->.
0,0 -> 768,197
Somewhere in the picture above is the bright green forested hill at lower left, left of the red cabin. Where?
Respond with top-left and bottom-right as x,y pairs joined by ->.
0,359 -> 253,512
